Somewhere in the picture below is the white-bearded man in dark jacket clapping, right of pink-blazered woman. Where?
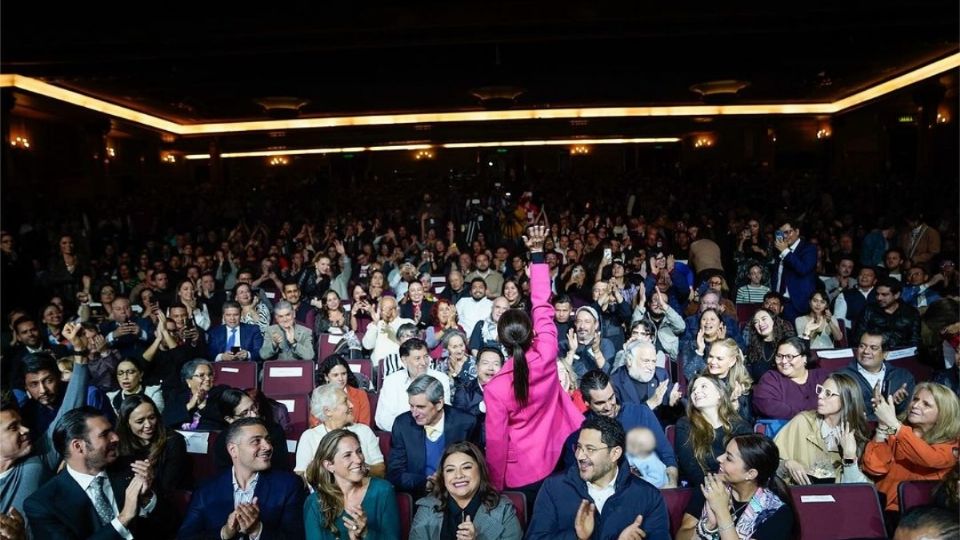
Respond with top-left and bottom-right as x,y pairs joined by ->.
610,341 -> 681,411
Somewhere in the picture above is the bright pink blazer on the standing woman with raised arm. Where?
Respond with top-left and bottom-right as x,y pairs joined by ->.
483,264 -> 583,490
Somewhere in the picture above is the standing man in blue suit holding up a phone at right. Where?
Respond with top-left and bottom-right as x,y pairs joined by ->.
772,221 -> 817,323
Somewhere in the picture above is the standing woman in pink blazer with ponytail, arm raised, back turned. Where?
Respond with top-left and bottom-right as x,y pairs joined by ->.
483,226 -> 583,493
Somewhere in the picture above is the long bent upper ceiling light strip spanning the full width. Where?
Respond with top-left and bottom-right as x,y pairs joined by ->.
0,53 -> 960,135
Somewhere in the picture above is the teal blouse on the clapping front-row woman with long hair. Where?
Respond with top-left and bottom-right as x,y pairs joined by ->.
303,478 -> 400,540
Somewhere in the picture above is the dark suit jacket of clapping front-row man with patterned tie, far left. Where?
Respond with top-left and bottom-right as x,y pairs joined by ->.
23,469 -> 164,540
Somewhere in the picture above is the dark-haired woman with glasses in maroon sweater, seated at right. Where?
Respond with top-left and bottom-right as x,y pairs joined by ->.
753,337 -> 829,420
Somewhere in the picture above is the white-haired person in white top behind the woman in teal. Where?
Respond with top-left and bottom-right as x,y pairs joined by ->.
293,383 -> 386,478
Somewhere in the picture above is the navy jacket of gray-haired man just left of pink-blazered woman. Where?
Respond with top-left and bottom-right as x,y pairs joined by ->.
387,407 -> 477,498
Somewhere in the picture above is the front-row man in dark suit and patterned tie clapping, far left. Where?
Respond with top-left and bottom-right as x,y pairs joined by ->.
24,406 -> 162,540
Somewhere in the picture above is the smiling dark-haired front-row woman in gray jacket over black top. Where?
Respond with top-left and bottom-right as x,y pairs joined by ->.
410,442 -> 523,540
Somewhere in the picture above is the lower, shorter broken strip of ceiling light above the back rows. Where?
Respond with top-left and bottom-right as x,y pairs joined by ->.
184,137 -> 680,160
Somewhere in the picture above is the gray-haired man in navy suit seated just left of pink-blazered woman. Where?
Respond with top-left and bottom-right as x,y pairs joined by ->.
387,375 -> 476,499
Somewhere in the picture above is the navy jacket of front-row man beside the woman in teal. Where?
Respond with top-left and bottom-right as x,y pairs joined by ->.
177,468 -> 306,540
